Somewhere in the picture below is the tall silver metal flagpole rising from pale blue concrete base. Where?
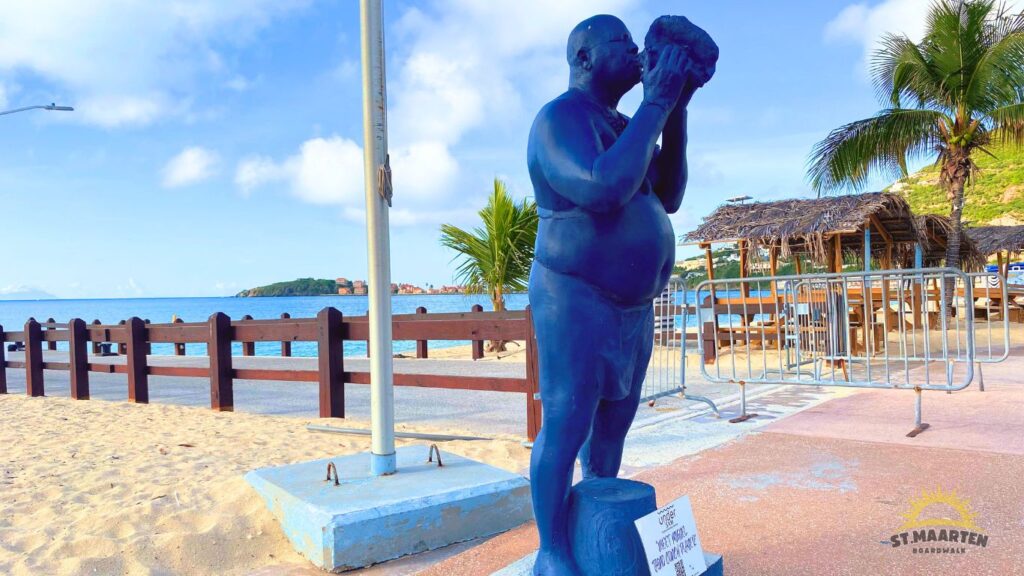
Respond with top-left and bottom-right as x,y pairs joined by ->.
359,0 -> 396,476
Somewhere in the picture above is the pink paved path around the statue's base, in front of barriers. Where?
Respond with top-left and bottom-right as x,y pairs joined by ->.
422,356 -> 1024,576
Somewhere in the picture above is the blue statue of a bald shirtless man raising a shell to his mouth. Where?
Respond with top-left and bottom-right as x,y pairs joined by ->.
527,15 -> 717,576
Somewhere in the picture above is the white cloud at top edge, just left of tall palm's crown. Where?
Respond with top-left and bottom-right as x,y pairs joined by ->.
824,0 -> 1024,71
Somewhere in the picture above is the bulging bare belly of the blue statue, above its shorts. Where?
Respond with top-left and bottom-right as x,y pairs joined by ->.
537,193 -> 676,303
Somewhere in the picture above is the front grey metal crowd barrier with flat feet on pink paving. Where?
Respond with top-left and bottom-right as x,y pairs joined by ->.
695,269 -> 1010,434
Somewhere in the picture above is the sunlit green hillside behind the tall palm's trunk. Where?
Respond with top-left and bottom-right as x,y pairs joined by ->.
887,141 -> 1024,227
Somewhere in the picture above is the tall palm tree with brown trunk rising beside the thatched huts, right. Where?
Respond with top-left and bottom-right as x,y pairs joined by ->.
808,0 -> 1024,276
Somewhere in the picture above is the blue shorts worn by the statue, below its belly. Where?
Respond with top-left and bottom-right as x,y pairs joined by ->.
529,260 -> 654,399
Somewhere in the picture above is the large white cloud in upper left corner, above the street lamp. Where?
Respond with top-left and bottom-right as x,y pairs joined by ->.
0,0 -> 308,126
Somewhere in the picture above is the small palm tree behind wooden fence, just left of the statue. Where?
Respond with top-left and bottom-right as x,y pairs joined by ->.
441,178 -> 537,352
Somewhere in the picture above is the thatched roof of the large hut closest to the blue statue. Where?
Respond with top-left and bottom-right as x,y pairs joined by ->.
684,193 -> 921,263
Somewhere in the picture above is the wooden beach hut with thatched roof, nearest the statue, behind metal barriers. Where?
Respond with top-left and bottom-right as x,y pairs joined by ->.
684,193 -> 984,362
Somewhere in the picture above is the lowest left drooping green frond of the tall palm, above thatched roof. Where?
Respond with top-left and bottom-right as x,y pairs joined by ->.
808,109 -> 946,194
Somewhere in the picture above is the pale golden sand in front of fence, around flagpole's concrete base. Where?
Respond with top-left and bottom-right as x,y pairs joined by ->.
0,395 -> 529,576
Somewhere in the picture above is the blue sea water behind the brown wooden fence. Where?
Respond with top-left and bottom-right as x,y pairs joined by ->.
0,294 -> 527,357
